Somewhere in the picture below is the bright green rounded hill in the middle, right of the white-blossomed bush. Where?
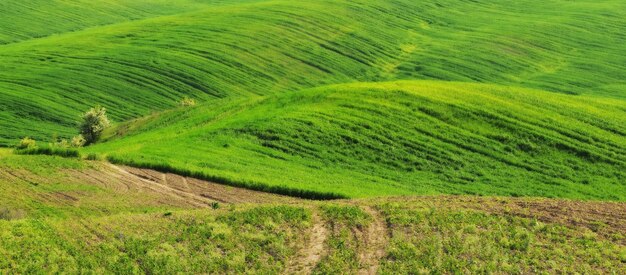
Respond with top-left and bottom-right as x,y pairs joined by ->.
85,81 -> 626,200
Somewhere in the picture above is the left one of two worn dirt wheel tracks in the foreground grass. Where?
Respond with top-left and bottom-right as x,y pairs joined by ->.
285,212 -> 328,274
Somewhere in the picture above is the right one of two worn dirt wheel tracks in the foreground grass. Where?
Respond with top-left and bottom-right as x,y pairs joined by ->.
359,206 -> 389,274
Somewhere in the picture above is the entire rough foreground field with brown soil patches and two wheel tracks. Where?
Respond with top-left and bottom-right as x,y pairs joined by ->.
0,153 -> 626,274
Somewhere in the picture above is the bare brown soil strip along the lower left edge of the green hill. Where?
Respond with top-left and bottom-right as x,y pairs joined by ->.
0,163 -> 302,211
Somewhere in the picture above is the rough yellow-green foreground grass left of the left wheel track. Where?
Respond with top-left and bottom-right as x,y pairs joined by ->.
0,206 -> 310,274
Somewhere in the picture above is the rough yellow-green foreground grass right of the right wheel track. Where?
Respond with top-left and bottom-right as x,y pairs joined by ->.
380,202 -> 626,274
